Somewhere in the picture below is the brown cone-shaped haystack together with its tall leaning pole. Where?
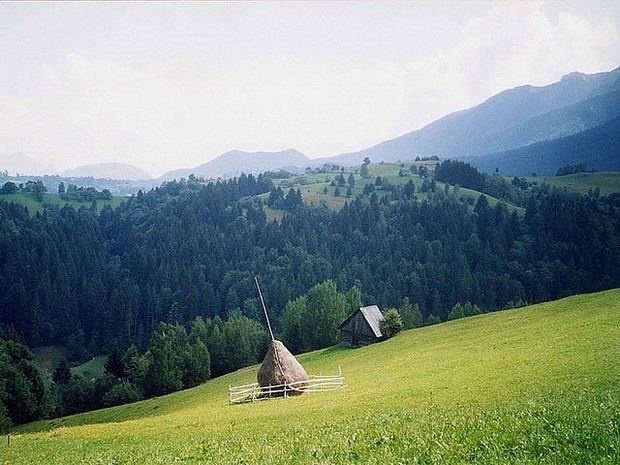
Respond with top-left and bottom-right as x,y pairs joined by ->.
254,277 -> 308,397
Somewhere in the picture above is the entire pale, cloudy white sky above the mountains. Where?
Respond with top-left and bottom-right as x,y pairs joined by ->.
0,0 -> 620,176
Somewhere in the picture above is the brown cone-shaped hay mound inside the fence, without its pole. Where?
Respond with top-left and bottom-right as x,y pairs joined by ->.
257,340 -> 308,396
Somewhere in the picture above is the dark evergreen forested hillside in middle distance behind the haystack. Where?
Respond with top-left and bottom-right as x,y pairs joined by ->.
0,161 -> 620,424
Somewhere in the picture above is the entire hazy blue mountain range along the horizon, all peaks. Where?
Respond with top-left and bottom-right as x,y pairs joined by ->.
0,68 -> 620,182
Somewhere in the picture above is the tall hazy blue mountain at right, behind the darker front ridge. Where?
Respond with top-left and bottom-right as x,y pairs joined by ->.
324,68 -> 620,174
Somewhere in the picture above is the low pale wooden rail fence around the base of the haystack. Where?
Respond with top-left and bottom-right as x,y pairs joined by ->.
228,370 -> 346,404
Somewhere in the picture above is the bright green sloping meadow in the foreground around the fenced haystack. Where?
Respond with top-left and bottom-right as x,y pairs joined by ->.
0,290 -> 620,465
